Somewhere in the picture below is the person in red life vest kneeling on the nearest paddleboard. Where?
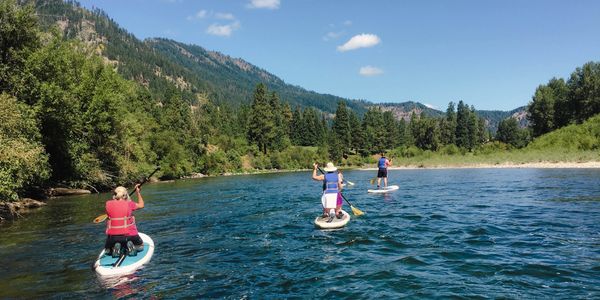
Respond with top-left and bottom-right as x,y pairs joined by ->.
104,184 -> 144,257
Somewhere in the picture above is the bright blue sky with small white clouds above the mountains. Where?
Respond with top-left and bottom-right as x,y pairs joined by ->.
81,0 -> 600,110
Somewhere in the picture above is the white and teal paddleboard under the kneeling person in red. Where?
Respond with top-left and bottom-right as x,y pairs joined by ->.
94,232 -> 154,276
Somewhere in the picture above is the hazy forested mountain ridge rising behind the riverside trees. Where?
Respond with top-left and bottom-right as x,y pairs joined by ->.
29,0 -> 524,131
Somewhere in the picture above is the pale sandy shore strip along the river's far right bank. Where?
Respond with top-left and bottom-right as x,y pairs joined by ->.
360,161 -> 600,171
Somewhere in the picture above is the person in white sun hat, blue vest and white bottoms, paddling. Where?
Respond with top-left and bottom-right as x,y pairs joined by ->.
312,162 -> 344,219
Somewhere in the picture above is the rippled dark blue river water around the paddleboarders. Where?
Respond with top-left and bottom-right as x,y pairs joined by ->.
0,169 -> 600,299
